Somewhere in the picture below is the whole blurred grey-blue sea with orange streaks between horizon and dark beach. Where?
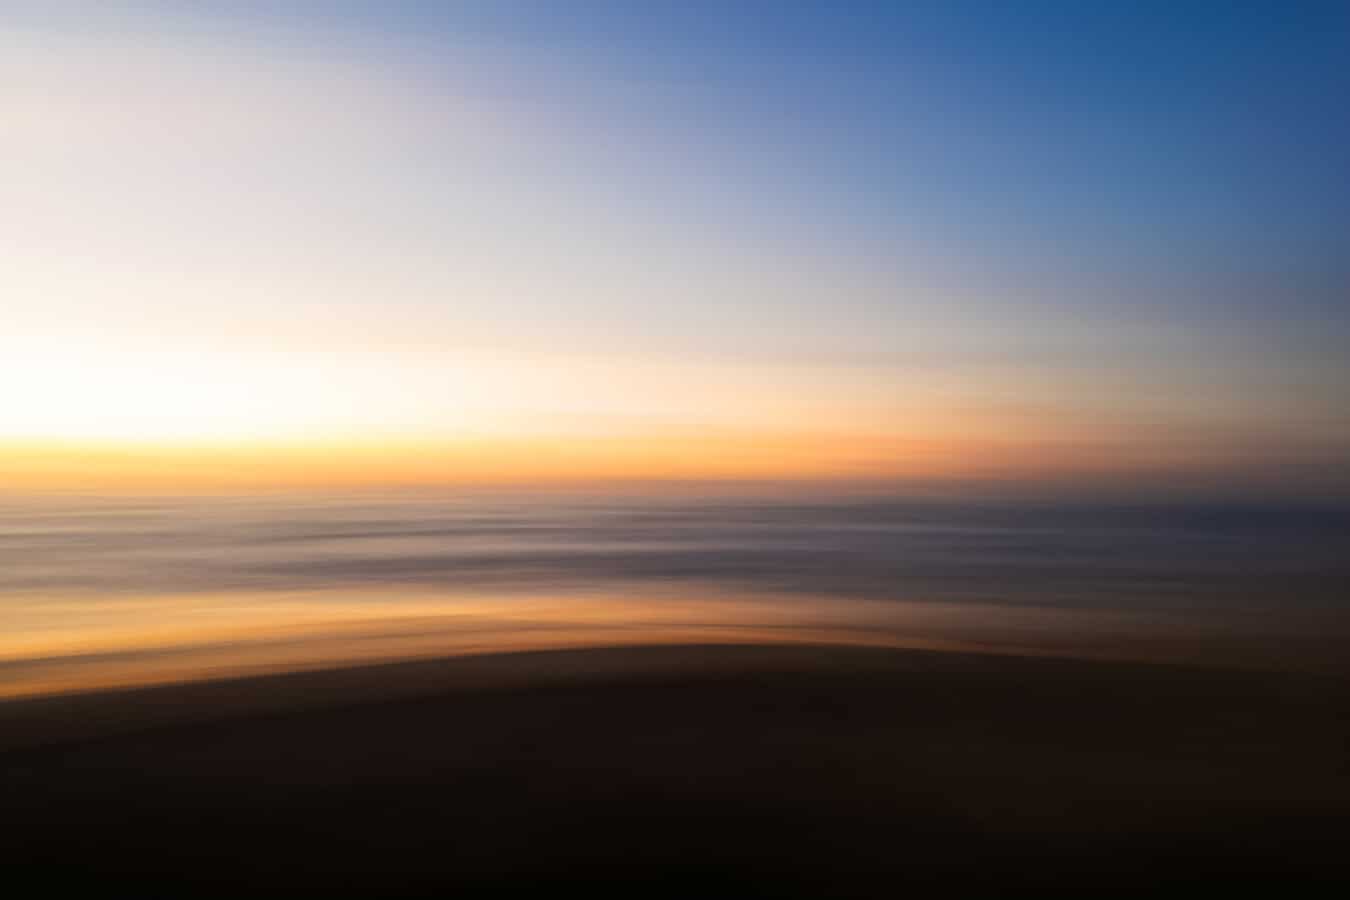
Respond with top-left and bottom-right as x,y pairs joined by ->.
0,490 -> 1350,698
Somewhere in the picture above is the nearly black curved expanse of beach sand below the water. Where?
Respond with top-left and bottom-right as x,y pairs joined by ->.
0,646 -> 1350,897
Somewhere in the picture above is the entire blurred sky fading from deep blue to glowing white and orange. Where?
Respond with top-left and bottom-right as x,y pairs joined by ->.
0,0 -> 1350,497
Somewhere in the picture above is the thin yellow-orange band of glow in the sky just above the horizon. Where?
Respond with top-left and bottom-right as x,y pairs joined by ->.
0,429 -> 1161,490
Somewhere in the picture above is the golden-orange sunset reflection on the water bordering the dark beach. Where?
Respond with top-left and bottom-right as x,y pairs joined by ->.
0,590 -> 1317,698
